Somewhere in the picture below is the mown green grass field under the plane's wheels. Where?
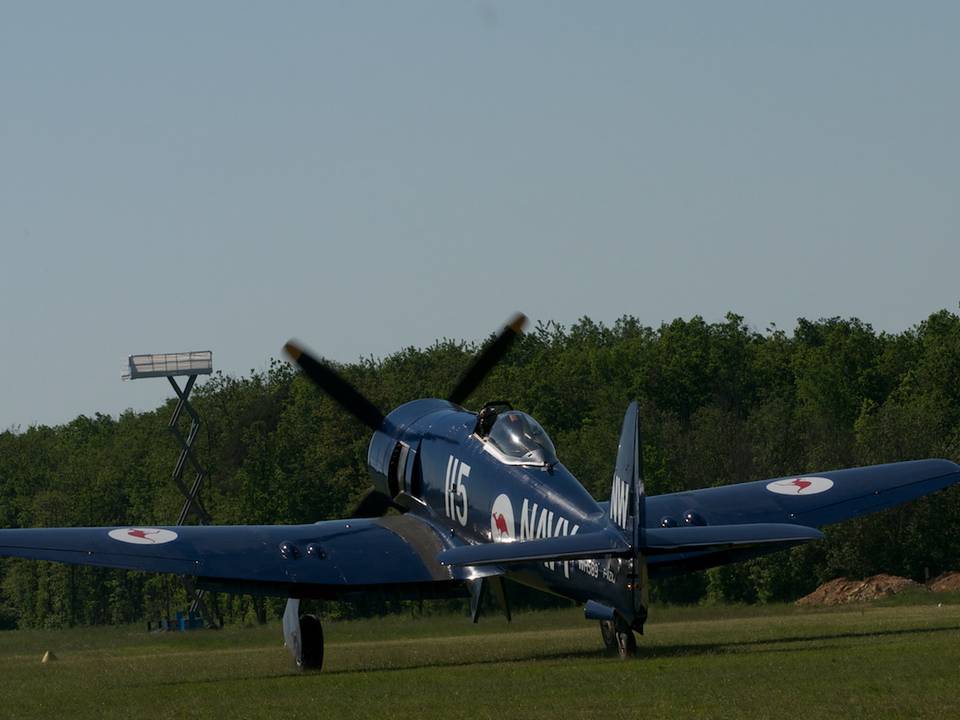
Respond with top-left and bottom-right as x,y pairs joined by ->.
0,597 -> 960,720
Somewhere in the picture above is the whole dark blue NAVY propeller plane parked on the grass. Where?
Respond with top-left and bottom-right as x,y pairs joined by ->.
0,315 -> 960,669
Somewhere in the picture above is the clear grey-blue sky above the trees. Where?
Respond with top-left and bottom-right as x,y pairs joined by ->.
0,1 -> 960,428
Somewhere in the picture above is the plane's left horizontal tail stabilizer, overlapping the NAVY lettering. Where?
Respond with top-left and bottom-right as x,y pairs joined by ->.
437,530 -> 630,565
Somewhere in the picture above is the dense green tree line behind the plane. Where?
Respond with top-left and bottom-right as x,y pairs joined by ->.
0,310 -> 960,627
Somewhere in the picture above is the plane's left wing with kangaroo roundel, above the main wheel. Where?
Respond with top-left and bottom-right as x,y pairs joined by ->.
0,515 -> 476,597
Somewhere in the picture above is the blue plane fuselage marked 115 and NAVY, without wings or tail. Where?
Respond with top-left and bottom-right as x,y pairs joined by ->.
368,399 -> 643,606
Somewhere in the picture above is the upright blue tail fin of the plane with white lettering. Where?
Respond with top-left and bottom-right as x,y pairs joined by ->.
610,401 -> 646,548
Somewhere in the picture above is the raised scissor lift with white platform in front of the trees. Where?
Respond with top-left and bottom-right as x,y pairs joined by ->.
123,350 -> 222,626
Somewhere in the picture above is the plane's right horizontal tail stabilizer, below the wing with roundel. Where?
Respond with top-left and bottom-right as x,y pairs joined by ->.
642,523 -> 823,555
